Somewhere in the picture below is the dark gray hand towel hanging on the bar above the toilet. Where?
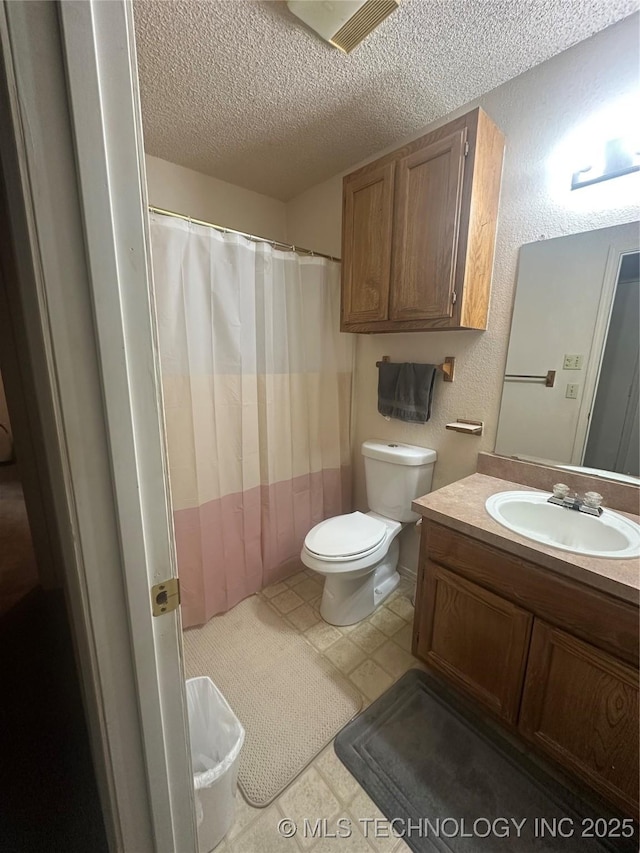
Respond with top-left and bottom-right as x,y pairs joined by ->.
378,361 -> 437,424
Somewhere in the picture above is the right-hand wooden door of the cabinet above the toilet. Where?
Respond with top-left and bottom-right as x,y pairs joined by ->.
389,128 -> 467,320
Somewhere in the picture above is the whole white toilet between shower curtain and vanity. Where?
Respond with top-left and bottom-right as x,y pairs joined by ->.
300,441 -> 437,625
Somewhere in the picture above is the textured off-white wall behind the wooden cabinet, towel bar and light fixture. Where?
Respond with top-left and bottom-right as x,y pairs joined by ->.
287,15 -> 640,508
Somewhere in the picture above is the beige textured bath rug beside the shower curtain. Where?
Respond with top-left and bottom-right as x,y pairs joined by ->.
184,596 -> 361,808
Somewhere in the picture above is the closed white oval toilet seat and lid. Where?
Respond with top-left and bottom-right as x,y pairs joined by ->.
304,512 -> 388,562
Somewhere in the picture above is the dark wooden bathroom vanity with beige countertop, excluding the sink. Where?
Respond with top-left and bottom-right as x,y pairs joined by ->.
413,474 -> 640,818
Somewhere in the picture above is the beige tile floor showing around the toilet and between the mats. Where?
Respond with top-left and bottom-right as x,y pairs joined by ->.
216,570 -> 420,853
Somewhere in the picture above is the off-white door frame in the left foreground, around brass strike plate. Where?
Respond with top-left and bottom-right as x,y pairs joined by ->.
0,0 -> 197,853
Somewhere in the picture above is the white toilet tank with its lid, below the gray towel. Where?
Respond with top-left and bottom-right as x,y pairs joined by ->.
362,441 -> 438,521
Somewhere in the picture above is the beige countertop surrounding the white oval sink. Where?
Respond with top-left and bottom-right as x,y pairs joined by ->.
412,474 -> 640,604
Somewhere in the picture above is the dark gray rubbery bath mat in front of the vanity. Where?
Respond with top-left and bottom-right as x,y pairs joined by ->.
335,669 -> 638,853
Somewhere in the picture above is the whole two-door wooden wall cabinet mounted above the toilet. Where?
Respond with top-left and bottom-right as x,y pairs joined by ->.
340,109 -> 504,333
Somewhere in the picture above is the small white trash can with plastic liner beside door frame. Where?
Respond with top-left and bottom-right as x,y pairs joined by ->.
187,676 -> 244,853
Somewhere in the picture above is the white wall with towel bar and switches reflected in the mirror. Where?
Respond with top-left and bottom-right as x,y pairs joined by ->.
496,223 -> 640,465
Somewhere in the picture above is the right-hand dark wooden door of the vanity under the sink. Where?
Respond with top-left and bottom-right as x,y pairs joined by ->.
519,620 -> 639,816
